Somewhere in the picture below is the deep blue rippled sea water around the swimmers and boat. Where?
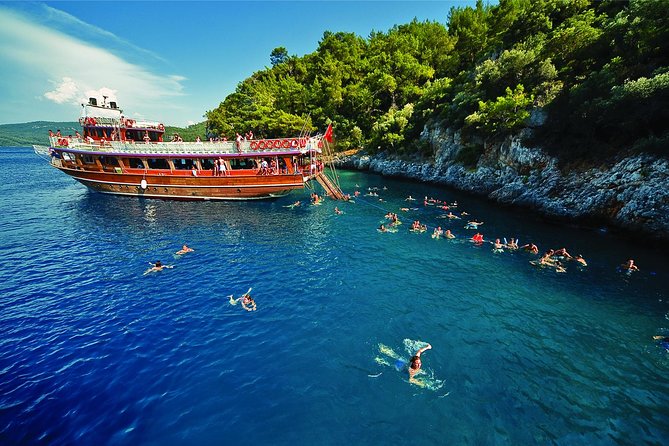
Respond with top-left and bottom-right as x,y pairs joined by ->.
0,148 -> 669,445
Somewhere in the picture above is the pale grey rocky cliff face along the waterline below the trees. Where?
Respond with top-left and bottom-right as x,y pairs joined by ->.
340,123 -> 669,241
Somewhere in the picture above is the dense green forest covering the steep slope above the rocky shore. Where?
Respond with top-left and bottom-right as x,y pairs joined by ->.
206,0 -> 669,161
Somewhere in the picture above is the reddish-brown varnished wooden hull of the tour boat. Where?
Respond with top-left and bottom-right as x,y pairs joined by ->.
56,166 -> 304,200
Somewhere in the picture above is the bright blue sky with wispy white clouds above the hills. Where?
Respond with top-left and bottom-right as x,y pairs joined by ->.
0,0 -> 474,127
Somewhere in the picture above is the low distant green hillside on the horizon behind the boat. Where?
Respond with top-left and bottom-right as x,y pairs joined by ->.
0,121 -> 206,147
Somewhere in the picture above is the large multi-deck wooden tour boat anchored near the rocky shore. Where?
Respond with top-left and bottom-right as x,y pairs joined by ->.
34,98 -> 331,200
